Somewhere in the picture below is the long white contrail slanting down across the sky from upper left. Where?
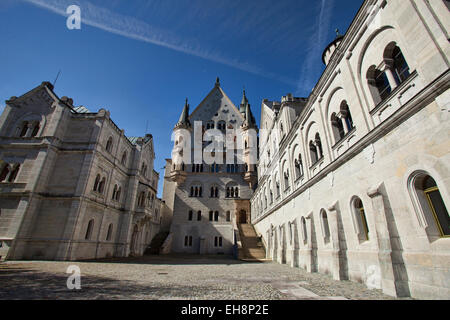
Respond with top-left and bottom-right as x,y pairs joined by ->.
23,0 -> 296,87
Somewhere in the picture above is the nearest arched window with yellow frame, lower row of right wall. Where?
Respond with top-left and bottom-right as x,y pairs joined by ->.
414,174 -> 450,237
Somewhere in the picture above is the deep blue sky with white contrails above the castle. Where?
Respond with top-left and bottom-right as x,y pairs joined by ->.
0,0 -> 362,193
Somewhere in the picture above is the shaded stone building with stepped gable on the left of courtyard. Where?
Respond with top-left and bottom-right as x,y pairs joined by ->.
0,82 -> 165,260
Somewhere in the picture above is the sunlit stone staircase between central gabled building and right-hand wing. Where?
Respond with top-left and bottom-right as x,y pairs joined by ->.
238,224 -> 267,262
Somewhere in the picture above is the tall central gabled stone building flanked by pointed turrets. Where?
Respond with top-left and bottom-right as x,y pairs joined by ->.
163,79 -> 257,254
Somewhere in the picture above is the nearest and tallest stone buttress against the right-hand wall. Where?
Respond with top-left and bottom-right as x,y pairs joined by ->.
367,183 -> 398,297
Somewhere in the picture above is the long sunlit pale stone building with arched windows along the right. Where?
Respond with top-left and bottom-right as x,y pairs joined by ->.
251,0 -> 450,299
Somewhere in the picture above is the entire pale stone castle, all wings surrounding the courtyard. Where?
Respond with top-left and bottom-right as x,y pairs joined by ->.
0,0 -> 450,299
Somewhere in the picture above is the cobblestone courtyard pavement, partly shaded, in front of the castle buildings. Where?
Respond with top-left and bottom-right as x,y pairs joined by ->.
0,255 -> 412,300
